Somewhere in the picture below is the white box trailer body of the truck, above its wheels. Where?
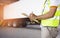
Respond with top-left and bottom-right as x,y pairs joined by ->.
4,0 -> 44,27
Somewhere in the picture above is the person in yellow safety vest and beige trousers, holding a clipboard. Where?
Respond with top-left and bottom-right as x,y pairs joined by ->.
29,0 -> 60,38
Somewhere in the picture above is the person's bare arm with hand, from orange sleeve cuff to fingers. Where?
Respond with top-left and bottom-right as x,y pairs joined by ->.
29,6 -> 57,20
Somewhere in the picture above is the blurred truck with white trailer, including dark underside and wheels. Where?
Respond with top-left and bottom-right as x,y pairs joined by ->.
2,0 -> 42,27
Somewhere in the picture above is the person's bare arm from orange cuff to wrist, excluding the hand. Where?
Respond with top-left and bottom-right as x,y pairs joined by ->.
36,6 -> 57,19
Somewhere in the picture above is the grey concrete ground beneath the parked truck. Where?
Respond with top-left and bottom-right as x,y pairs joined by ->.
0,25 -> 60,38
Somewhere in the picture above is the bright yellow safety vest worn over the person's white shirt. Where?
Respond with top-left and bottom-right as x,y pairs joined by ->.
41,0 -> 60,27
